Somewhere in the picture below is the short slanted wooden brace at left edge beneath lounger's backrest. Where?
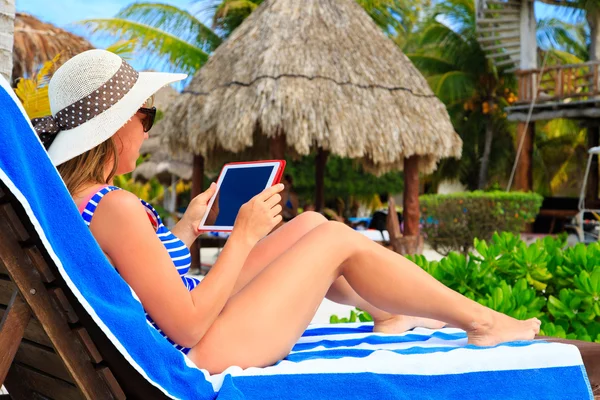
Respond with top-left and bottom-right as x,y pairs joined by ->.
0,290 -> 31,385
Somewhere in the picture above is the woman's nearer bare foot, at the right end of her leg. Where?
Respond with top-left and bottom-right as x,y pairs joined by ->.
467,310 -> 541,346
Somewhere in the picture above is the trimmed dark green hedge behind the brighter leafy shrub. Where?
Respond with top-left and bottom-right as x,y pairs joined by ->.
419,192 -> 542,255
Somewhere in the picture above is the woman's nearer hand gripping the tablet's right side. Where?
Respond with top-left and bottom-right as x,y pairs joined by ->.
233,183 -> 283,245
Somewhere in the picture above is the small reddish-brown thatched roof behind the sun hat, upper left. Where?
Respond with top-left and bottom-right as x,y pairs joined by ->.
12,10 -> 94,79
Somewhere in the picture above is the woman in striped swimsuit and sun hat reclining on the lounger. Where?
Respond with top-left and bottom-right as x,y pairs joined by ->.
34,50 -> 540,373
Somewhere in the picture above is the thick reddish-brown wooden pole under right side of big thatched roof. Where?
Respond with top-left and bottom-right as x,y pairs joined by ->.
402,156 -> 420,236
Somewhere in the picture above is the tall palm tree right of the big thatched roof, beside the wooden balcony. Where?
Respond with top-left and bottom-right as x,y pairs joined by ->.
408,0 -> 515,189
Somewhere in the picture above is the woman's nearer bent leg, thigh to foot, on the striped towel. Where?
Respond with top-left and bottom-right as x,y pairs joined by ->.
189,223 -> 539,373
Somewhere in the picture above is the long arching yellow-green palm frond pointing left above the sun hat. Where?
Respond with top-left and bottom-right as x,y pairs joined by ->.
79,18 -> 208,74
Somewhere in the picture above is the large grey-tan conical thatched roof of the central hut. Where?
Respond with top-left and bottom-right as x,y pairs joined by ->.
165,0 -> 462,173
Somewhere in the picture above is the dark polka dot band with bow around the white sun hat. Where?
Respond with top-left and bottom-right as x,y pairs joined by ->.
31,60 -> 139,149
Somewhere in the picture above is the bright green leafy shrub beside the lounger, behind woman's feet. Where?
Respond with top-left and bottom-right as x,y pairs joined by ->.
331,233 -> 600,343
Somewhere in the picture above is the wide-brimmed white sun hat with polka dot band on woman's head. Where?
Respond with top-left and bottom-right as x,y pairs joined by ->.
32,50 -> 187,165
